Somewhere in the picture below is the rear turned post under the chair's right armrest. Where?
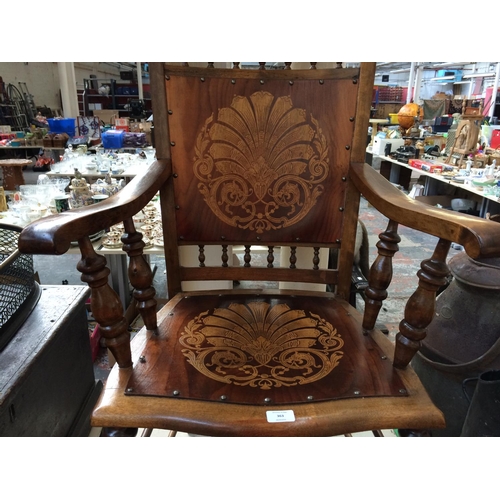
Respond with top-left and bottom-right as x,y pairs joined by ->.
363,220 -> 401,331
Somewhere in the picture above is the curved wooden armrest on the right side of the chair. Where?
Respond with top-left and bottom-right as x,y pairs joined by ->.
351,163 -> 500,259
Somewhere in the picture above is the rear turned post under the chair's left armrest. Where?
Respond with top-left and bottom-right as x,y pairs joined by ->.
122,219 -> 157,331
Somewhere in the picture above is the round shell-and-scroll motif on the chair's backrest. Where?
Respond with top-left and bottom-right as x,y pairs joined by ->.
194,91 -> 329,233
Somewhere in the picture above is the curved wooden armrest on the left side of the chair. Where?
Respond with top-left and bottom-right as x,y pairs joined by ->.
18,160 -> 171,255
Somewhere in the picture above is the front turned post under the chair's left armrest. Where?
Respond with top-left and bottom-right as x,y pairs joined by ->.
77,236 -> 132,368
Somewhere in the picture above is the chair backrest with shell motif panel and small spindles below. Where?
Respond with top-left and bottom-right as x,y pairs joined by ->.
150,63 -> 374,294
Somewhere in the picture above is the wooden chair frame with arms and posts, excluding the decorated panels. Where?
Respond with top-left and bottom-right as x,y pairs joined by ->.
19,63 -> 500,436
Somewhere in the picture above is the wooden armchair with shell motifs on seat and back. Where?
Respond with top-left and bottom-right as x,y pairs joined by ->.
19,63 -> 500,436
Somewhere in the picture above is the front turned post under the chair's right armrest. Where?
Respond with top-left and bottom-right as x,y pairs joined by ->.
394,239 -> 451,368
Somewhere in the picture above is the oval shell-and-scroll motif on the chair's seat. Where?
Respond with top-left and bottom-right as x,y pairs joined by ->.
179,302 -> 344,390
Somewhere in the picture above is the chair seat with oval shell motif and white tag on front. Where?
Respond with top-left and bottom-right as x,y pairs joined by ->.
92,290 -> 444,436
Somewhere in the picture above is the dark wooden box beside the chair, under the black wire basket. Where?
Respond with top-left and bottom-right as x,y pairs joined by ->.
0,286 -> 102,437
